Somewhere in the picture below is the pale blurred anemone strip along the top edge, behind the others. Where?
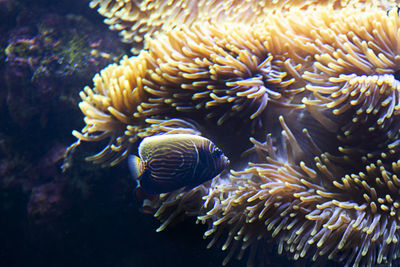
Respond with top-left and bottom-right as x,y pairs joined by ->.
90,0 -> 395,54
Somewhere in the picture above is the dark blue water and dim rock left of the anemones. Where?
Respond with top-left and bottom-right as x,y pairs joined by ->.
0,0 -> 245,267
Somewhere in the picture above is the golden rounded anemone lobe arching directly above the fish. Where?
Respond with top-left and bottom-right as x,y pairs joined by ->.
67,23 -> 304,165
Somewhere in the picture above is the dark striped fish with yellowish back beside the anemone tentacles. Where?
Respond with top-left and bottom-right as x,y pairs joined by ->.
128,134 -> 229,194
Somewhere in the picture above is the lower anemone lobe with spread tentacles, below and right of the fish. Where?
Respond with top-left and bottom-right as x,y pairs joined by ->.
198,117 -> 400,266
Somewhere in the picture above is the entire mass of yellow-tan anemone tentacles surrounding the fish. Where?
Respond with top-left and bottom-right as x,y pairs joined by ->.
71,0 -> 400,266
